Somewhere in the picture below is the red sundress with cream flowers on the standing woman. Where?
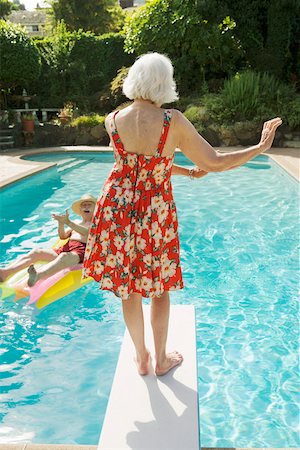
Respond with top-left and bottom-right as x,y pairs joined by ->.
83,110 -> 183,299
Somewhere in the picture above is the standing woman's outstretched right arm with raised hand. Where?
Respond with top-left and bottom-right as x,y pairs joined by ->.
176,111 -> 282,172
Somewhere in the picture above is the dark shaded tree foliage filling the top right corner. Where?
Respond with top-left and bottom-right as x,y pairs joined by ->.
218,0 -> 300,79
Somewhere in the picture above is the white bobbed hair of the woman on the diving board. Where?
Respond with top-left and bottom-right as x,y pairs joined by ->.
123,53 -> 178,105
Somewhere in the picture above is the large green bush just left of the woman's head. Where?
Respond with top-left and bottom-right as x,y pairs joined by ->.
31,26 -> 134,111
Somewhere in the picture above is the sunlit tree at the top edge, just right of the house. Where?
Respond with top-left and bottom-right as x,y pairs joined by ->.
52,0 -> 124,34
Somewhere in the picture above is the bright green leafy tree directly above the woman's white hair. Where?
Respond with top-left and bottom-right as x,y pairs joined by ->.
125,0 -> 241,91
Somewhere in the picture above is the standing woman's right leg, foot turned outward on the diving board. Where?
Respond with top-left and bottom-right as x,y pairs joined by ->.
151,291 -> 183,375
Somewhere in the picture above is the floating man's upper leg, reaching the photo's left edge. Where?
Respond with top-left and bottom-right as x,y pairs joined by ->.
0,249 -> 57,282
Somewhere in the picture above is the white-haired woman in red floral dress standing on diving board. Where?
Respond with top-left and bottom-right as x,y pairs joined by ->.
84,53 -> 281,375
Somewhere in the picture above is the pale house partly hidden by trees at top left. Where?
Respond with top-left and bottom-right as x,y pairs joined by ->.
8,8 -> 47,36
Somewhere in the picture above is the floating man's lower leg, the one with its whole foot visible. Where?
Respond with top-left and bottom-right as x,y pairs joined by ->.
28,252 -> 80,287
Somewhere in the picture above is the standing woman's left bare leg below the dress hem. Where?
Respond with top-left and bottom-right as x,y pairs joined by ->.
122,293 -> 150,375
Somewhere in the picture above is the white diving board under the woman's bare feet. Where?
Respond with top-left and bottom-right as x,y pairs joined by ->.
98,305 -> 200,450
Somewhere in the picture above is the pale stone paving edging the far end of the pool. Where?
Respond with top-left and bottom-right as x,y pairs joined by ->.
0,145 -> 300,189
